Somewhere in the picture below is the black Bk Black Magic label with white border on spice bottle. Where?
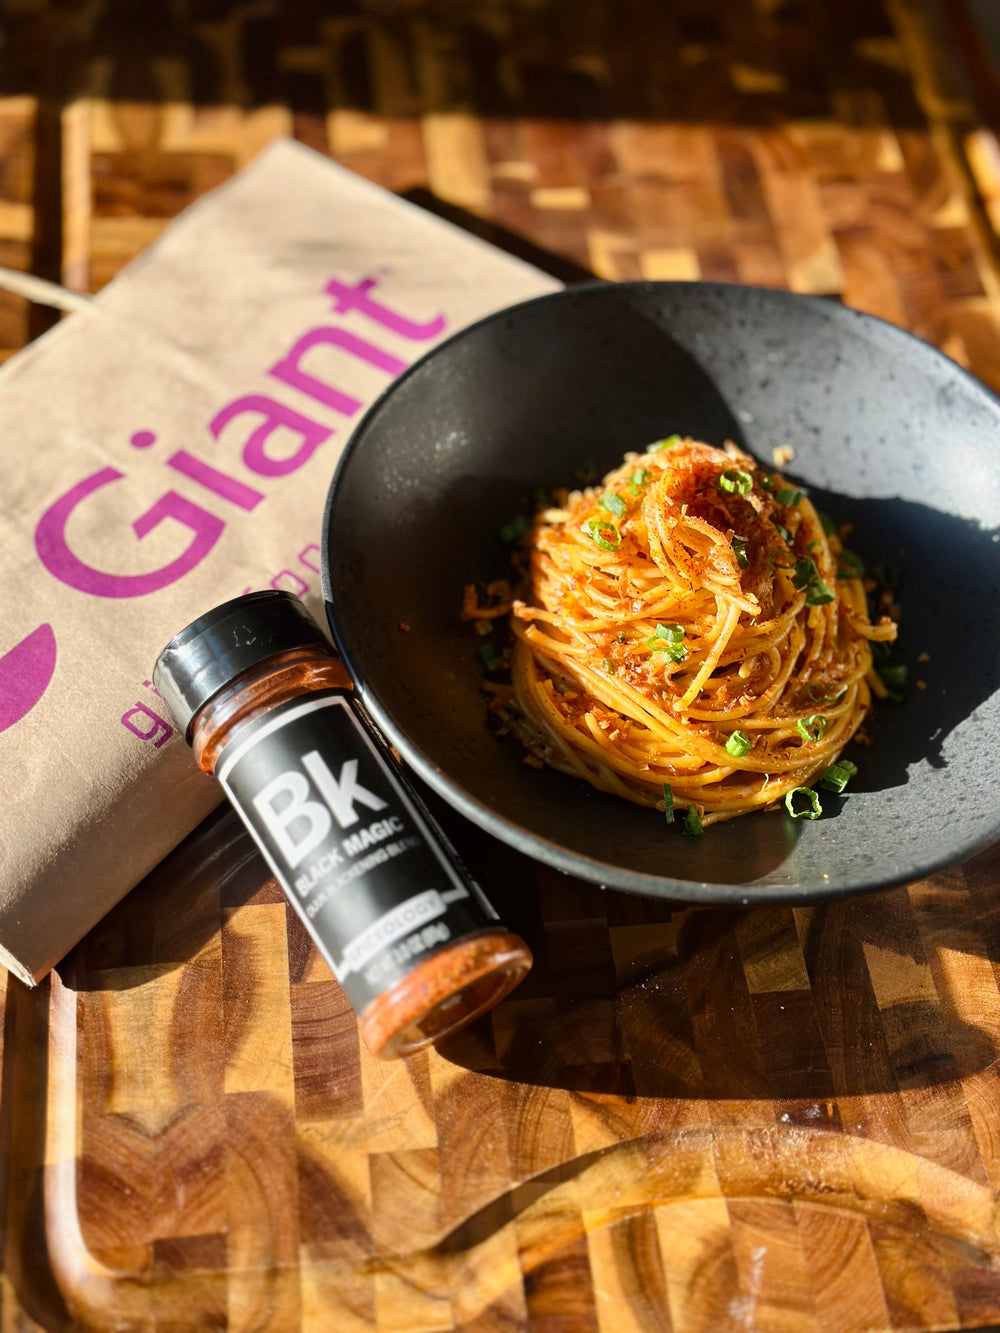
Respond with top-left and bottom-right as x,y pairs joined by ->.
216,693 -> 496,1013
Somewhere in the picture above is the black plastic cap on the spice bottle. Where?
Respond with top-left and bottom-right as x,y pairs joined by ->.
153,589 -> 332,736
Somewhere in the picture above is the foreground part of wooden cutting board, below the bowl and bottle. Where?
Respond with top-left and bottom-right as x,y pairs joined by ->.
3,812 -> 1000,1333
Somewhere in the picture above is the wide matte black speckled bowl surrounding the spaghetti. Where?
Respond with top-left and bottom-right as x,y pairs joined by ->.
323,283 -> 1000,902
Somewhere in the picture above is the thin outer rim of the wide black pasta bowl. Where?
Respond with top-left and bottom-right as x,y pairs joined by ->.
320,279 -> 1000,906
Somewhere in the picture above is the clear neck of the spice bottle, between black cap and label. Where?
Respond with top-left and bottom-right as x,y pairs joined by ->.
188,644 -> 351,773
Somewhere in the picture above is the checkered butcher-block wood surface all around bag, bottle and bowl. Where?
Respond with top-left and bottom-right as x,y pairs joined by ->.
0,0 -> 1000,1333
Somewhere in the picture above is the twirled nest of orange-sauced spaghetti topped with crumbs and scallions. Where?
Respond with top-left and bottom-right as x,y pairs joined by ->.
482,436 -> 896,825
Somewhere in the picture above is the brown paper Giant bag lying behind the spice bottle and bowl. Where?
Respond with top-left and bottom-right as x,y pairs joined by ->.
0,141 -> 557,982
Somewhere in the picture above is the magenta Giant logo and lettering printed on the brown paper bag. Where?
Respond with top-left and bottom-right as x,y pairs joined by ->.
0,277 -> 447,749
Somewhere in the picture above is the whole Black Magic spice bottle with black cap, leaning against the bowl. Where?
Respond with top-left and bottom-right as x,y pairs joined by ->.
153,592 -> 532,1058
